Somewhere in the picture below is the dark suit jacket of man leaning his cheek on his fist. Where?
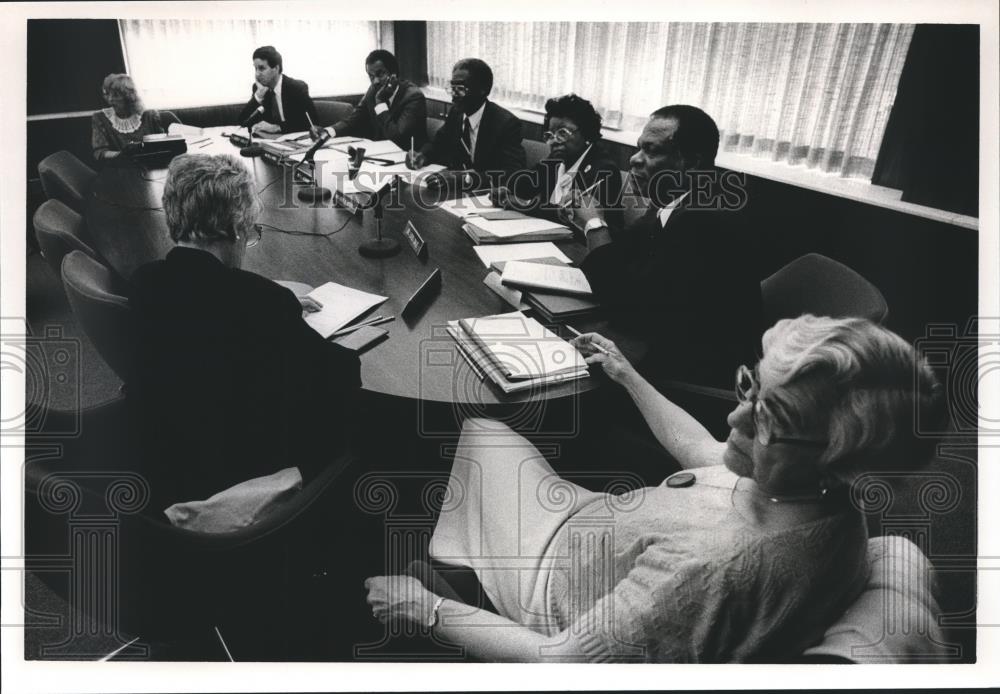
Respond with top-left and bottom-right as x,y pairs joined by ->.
333,80 -> 427,150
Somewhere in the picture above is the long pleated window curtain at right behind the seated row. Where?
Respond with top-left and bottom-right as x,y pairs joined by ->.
427,22 -> 913,179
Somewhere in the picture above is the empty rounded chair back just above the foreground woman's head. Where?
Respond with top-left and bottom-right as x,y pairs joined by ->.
760,253 -> 889,326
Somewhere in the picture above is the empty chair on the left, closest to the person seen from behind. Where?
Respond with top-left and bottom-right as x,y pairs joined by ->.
62,250 -> 131,383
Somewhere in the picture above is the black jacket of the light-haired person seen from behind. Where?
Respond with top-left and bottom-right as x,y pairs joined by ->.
126,247 -> 361,511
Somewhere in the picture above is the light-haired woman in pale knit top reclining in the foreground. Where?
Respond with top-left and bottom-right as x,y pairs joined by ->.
366,316 -> 941,662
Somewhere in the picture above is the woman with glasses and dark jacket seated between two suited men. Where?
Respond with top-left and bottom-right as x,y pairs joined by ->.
493,94 -> 622,230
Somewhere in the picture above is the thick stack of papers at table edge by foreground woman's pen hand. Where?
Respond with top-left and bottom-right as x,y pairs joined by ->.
448,311 -> 588,393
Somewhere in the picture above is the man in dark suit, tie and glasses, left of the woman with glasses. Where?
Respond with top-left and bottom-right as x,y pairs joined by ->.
407,58 -> 525,186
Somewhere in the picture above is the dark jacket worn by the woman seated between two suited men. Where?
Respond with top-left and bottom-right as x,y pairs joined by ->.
508,143 -> 623,231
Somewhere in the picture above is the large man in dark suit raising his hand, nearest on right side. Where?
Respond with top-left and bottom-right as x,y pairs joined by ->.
576,106 -> 764,388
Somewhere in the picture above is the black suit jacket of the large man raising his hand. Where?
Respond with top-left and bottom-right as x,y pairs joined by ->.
581,182 -> 764,388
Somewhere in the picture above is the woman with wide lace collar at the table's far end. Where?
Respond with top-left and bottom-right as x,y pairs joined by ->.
91,73 -> 166,161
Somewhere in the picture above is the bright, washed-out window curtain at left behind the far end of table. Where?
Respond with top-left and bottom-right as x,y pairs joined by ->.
119,19 -> 378,108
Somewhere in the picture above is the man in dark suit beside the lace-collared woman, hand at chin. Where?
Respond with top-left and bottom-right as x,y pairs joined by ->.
239,46 -> 316,134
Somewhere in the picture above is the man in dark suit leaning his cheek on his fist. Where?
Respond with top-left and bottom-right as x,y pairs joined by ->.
327,49 -> 427,150
